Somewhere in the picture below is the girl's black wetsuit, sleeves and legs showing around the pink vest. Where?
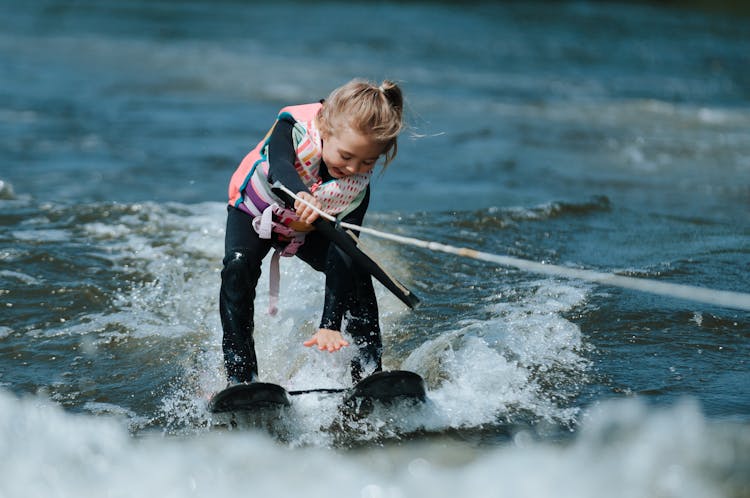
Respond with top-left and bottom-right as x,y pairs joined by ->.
219,118 -> 382,382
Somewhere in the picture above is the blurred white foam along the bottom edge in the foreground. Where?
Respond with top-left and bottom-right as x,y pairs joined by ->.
0,392 -> 750,498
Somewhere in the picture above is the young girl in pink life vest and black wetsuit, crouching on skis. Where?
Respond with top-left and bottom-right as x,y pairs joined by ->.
219,80 -> 403,383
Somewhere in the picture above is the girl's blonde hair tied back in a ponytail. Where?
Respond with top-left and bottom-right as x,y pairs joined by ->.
318,79 -> 404,166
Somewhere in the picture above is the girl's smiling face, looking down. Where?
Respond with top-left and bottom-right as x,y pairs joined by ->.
323,127 -> 385,178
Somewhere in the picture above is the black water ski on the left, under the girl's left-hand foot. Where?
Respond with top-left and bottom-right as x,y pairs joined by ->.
208,382 -> 291,413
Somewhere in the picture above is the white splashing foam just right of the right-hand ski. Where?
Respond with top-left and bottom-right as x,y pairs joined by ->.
403,280 -> 589,429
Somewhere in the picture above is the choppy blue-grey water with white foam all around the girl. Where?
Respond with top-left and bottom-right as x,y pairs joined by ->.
0,1 -> 750,497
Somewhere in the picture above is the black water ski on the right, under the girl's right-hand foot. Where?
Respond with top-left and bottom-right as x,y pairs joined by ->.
344,370 -> 427,412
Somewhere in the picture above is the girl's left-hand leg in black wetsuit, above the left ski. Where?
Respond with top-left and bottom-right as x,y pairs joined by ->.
219,206 -> 271,382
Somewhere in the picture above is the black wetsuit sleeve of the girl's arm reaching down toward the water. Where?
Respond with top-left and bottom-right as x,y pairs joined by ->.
320,186 -> 374,330
